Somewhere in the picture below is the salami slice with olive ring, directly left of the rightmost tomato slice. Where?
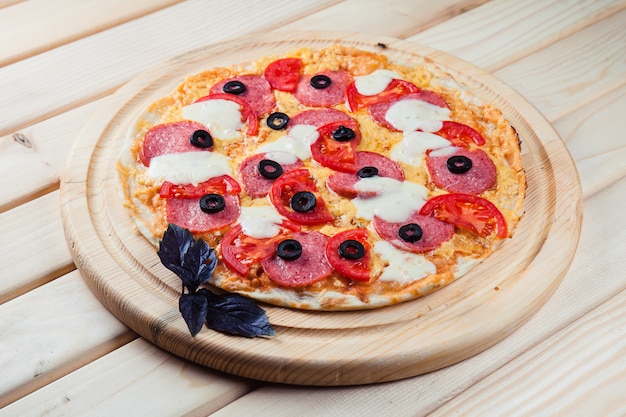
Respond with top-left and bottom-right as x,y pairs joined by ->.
373,212 -> 454,253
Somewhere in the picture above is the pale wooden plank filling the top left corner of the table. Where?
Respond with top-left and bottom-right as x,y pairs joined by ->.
0,0 -> 182,67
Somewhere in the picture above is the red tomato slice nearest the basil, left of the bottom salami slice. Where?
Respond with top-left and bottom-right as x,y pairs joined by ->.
220,220 -> 300,276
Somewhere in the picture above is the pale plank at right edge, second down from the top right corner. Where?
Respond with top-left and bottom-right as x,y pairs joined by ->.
495,10 -> 626,120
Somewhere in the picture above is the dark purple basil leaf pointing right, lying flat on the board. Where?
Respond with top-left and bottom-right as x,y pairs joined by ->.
198,289 -> 276,337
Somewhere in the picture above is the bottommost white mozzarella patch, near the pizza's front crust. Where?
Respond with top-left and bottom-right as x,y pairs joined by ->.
374,240 -> 437,284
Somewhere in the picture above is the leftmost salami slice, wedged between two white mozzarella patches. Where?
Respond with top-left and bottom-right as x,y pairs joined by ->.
139,120 -> 211,166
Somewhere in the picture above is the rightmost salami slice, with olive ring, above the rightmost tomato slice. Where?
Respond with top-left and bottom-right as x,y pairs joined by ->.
426,147 -> 497,194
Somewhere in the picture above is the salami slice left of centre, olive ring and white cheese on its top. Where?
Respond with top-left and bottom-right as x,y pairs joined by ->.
239,152 -> 304,198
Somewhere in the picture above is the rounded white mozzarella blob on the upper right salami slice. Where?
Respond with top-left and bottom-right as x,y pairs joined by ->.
385,99 -> 450,132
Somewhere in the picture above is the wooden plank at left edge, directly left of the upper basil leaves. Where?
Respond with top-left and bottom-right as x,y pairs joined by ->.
0,191 -> 75,304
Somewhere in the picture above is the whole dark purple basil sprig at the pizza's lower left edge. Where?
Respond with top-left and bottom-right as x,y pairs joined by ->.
157,224 -> 276,337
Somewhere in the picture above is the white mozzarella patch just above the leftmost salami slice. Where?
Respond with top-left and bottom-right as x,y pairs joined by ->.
183,99 -> 243,140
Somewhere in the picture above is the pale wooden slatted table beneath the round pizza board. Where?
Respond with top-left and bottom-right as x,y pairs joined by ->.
0,0 -> 626,417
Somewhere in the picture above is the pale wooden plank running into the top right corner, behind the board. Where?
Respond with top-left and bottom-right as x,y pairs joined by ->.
408,0 -> 626,71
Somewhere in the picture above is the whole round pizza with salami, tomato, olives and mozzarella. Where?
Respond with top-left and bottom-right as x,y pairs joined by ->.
117,45 -> 526,310
